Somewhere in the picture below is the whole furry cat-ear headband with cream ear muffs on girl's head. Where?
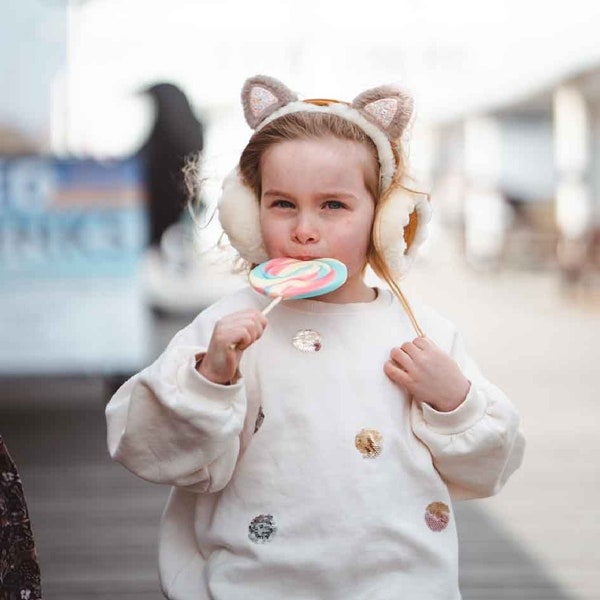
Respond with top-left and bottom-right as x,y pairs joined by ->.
218,76 -> 431,277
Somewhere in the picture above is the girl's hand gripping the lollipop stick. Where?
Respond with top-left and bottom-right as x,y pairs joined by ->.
196,310 -> 267,384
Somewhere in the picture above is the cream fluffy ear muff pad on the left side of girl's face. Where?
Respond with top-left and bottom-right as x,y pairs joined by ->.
218,168 -> 268,263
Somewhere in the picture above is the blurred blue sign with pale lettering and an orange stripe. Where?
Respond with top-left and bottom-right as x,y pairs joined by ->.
0,157 -> 148,281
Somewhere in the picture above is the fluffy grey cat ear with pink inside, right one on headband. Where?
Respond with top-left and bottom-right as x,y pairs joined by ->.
352,85 -> 413,140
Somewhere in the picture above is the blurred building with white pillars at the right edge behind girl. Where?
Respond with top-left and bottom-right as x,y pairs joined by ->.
432,66 -> 600,280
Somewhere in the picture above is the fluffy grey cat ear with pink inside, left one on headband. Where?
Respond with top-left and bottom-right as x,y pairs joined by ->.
242,75 -> 298,129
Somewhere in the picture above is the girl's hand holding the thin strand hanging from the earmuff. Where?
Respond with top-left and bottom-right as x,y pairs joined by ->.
383,337 -> 471,412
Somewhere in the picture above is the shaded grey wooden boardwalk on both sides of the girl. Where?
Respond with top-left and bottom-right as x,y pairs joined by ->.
0,379 -> 572,600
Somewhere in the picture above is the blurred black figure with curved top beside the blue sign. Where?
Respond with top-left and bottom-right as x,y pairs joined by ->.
139,83 -> 204,246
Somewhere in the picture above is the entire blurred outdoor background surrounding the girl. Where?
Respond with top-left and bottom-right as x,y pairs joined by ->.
0,0 -> 600,600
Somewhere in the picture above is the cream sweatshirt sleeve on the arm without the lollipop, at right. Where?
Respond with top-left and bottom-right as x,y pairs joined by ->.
411,333 -> 525,500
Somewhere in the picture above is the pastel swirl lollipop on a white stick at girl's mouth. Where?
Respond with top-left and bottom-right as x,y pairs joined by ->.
248,258 -> 348,315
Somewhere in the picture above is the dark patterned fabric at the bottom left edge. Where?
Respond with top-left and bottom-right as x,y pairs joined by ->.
0,436 -> 42,600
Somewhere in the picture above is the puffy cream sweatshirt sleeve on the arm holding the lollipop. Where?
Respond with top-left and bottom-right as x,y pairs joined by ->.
106,315 -> 246,492
